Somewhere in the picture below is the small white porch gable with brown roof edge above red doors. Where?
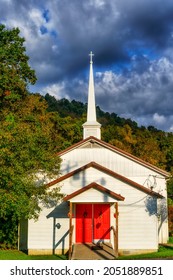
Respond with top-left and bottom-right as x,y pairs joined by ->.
64,182 -> 125,203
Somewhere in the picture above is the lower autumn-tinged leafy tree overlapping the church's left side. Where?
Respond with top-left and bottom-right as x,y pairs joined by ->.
0,95 -> 61,246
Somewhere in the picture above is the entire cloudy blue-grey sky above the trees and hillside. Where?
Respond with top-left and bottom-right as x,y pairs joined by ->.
0,0 -> 173,132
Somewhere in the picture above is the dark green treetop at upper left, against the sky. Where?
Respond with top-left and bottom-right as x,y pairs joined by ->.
0,24 -> 36,107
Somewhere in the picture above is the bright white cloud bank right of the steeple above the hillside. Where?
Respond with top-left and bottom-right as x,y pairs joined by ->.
93,57 -> 173,130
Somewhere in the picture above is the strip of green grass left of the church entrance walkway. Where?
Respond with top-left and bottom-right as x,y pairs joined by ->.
0,250 -> 67,260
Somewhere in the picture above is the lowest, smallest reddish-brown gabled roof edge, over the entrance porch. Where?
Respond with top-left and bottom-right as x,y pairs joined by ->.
64,182 -> 124,201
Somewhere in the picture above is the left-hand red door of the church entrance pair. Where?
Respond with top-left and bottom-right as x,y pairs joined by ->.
76,204 -> 92,243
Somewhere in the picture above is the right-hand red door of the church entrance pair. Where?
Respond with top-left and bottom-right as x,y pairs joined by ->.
94,204 -> 110,240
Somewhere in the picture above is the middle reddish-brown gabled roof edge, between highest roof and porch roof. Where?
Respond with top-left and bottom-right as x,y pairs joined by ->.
47,162 -> 163,198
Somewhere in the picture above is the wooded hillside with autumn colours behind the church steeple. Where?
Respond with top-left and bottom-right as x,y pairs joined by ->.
45,94 -> 173,172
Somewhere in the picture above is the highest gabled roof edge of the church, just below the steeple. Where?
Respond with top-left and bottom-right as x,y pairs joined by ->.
57,136 -> 169,177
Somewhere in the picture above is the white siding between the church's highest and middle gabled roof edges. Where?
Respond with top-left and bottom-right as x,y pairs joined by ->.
61,148 -> 166,196
